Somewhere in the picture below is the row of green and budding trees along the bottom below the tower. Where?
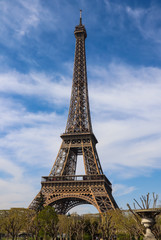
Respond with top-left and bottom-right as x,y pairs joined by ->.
0,206 -> 161,240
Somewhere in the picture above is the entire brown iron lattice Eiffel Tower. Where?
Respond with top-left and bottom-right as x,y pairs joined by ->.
29,11 -> 118,214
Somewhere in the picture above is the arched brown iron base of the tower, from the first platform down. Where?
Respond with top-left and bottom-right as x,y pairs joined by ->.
29,174 -> 118,214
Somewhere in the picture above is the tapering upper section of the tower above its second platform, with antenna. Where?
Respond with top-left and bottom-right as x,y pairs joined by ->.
65,10 -> 92,133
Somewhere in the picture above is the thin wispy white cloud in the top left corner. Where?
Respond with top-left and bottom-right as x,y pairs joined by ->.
0,0 -> 57,43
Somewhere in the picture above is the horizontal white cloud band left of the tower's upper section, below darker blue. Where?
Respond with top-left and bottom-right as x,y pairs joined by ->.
0,71 -> 71,104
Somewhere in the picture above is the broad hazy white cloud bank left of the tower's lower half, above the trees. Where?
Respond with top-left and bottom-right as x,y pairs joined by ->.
0,99 -> 64,208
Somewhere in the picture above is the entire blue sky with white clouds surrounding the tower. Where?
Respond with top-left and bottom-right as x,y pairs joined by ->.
0,0 -> 161,212
